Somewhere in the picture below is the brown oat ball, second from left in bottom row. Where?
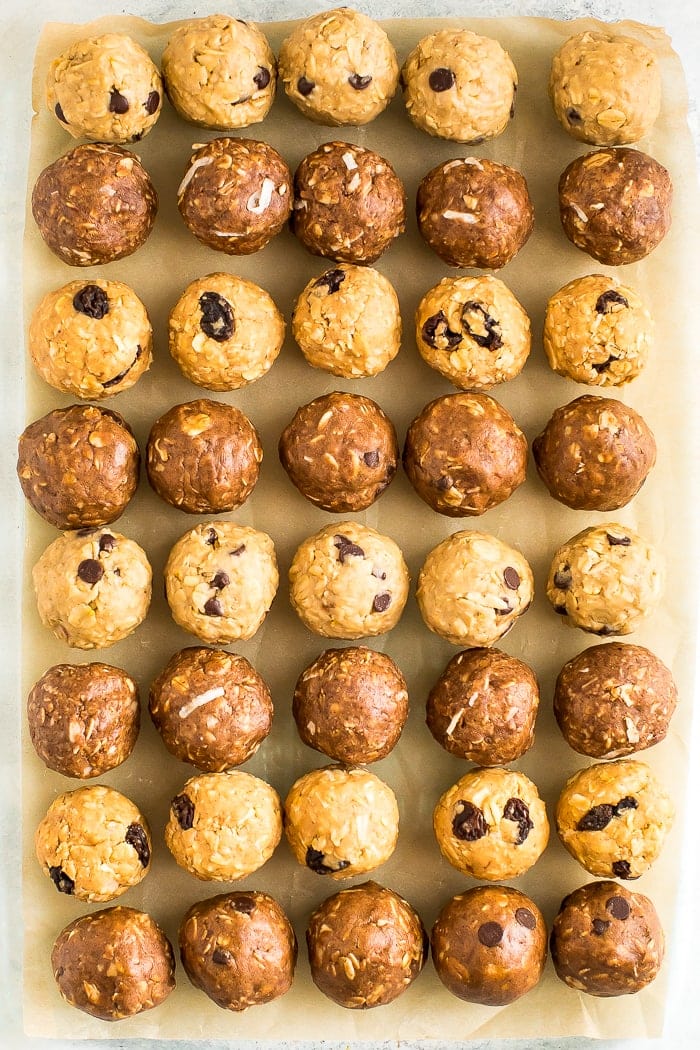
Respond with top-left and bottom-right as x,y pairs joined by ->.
179,889 -> 297,1012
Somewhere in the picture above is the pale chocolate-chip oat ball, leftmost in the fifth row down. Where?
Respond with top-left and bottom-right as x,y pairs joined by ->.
31,528 -> 151,649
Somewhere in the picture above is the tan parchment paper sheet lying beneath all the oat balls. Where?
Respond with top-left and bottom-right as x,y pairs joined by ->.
23,17 -> 700,1042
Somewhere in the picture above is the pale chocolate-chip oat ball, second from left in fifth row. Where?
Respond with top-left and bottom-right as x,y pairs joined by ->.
165,521 -> 279,645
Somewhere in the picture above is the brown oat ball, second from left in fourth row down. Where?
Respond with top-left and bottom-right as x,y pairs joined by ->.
146,398 -> 262,515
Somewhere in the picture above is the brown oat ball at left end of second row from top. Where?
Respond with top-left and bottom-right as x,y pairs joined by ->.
31,142 -> 158,266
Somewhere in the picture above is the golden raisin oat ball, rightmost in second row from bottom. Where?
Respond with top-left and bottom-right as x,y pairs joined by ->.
556,758 -> 675,879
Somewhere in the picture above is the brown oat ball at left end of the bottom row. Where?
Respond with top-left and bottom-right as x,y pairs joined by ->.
51,906 -> 175,1021
